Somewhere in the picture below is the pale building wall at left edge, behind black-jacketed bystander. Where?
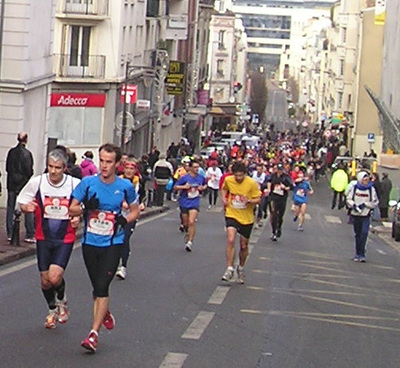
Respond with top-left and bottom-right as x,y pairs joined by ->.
0,0 -> 56,205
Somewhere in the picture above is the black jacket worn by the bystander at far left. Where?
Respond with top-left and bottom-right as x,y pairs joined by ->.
6,143 -> 33,192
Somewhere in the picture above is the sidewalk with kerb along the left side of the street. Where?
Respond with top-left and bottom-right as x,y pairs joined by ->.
0,206 -> 169,266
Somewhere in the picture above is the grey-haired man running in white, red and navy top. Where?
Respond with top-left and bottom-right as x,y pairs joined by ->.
17,150 -> 80,329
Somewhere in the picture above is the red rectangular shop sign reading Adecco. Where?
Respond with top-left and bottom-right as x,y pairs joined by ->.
50,92 -> 106,107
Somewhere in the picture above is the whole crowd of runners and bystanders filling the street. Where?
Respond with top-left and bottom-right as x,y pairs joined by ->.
0,124 -> 391,353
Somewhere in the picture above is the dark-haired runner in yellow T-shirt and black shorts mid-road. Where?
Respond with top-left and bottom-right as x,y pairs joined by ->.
222,162 -> 261,284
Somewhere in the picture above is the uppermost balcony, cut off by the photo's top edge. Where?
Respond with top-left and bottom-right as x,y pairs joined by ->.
57,0 -> 109,19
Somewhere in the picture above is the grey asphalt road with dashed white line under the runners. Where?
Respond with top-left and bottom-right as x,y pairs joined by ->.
0,181 -> 400,368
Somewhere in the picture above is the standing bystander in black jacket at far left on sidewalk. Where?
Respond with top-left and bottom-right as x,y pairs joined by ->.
6,132 -> 35,243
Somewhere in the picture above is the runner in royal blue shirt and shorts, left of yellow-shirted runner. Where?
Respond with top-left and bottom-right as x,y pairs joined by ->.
174,160 -> 207,252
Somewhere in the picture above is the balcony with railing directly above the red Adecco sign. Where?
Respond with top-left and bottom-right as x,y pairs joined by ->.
54,54 -> 106,79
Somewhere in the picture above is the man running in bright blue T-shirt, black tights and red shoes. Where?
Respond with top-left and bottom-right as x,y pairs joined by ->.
70,143 -> 139,353
